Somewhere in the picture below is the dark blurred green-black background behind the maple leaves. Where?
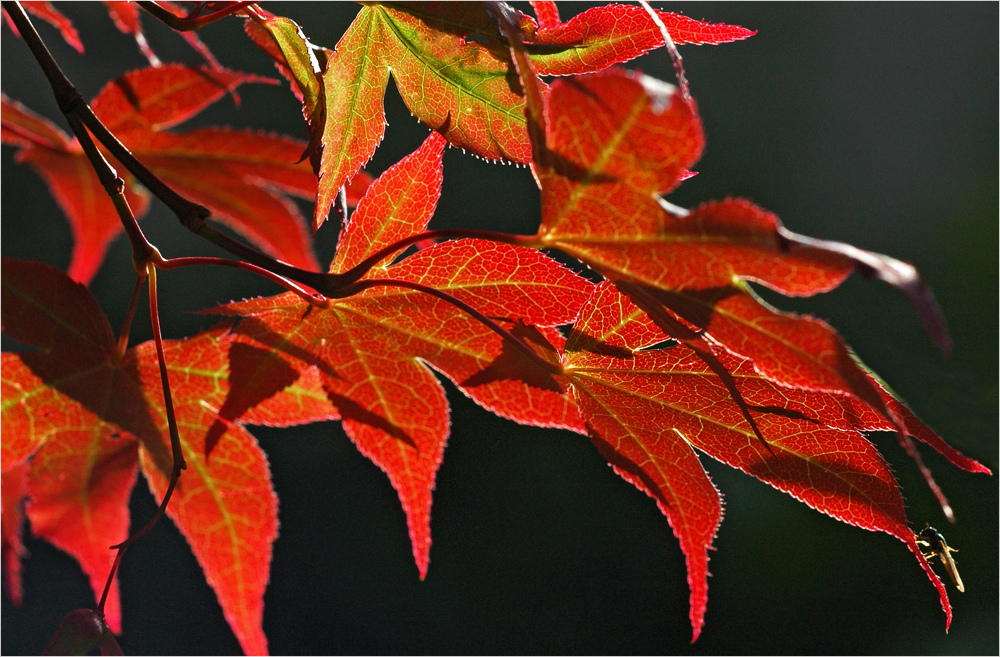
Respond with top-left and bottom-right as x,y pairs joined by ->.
0,3 -> 998,654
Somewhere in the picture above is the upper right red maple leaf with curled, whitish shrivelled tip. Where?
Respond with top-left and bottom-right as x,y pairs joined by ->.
533,70 -> 944,440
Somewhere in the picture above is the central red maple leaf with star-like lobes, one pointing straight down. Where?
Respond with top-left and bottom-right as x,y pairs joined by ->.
215,134 -> 591,577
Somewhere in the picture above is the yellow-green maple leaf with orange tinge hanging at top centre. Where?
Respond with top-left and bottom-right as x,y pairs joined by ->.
313,3 -> 530,230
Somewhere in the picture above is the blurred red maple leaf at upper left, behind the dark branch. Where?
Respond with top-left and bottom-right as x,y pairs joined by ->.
3,65 -> 317,282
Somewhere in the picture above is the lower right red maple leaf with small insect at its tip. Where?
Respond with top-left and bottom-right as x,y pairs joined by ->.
563,283 -> 988,638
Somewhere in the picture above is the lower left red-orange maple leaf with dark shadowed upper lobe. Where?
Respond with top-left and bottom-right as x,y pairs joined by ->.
2,259 -> 336,654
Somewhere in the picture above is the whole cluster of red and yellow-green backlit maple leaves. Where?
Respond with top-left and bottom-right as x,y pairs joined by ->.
2,2 -> 988,654
